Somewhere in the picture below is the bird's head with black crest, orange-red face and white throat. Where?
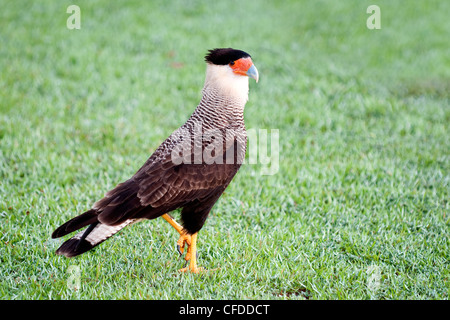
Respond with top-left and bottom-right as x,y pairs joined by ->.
205,48 -> 259,100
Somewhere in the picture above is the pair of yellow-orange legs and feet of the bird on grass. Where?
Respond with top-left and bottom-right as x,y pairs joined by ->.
162,213 -> 202,273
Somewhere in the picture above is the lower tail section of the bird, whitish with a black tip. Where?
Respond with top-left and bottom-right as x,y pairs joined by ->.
56,219 -> 137,258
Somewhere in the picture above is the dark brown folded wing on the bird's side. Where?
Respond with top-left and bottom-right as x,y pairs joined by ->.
94,131 -> 245,225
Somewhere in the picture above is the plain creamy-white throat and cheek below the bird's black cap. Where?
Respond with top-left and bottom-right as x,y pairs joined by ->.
203,63 -> 248,105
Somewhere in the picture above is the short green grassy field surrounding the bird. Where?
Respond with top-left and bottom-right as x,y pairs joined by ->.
0,0 -> 450,299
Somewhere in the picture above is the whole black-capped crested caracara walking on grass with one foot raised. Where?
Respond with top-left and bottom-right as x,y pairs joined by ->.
51,48 -> 259,273
